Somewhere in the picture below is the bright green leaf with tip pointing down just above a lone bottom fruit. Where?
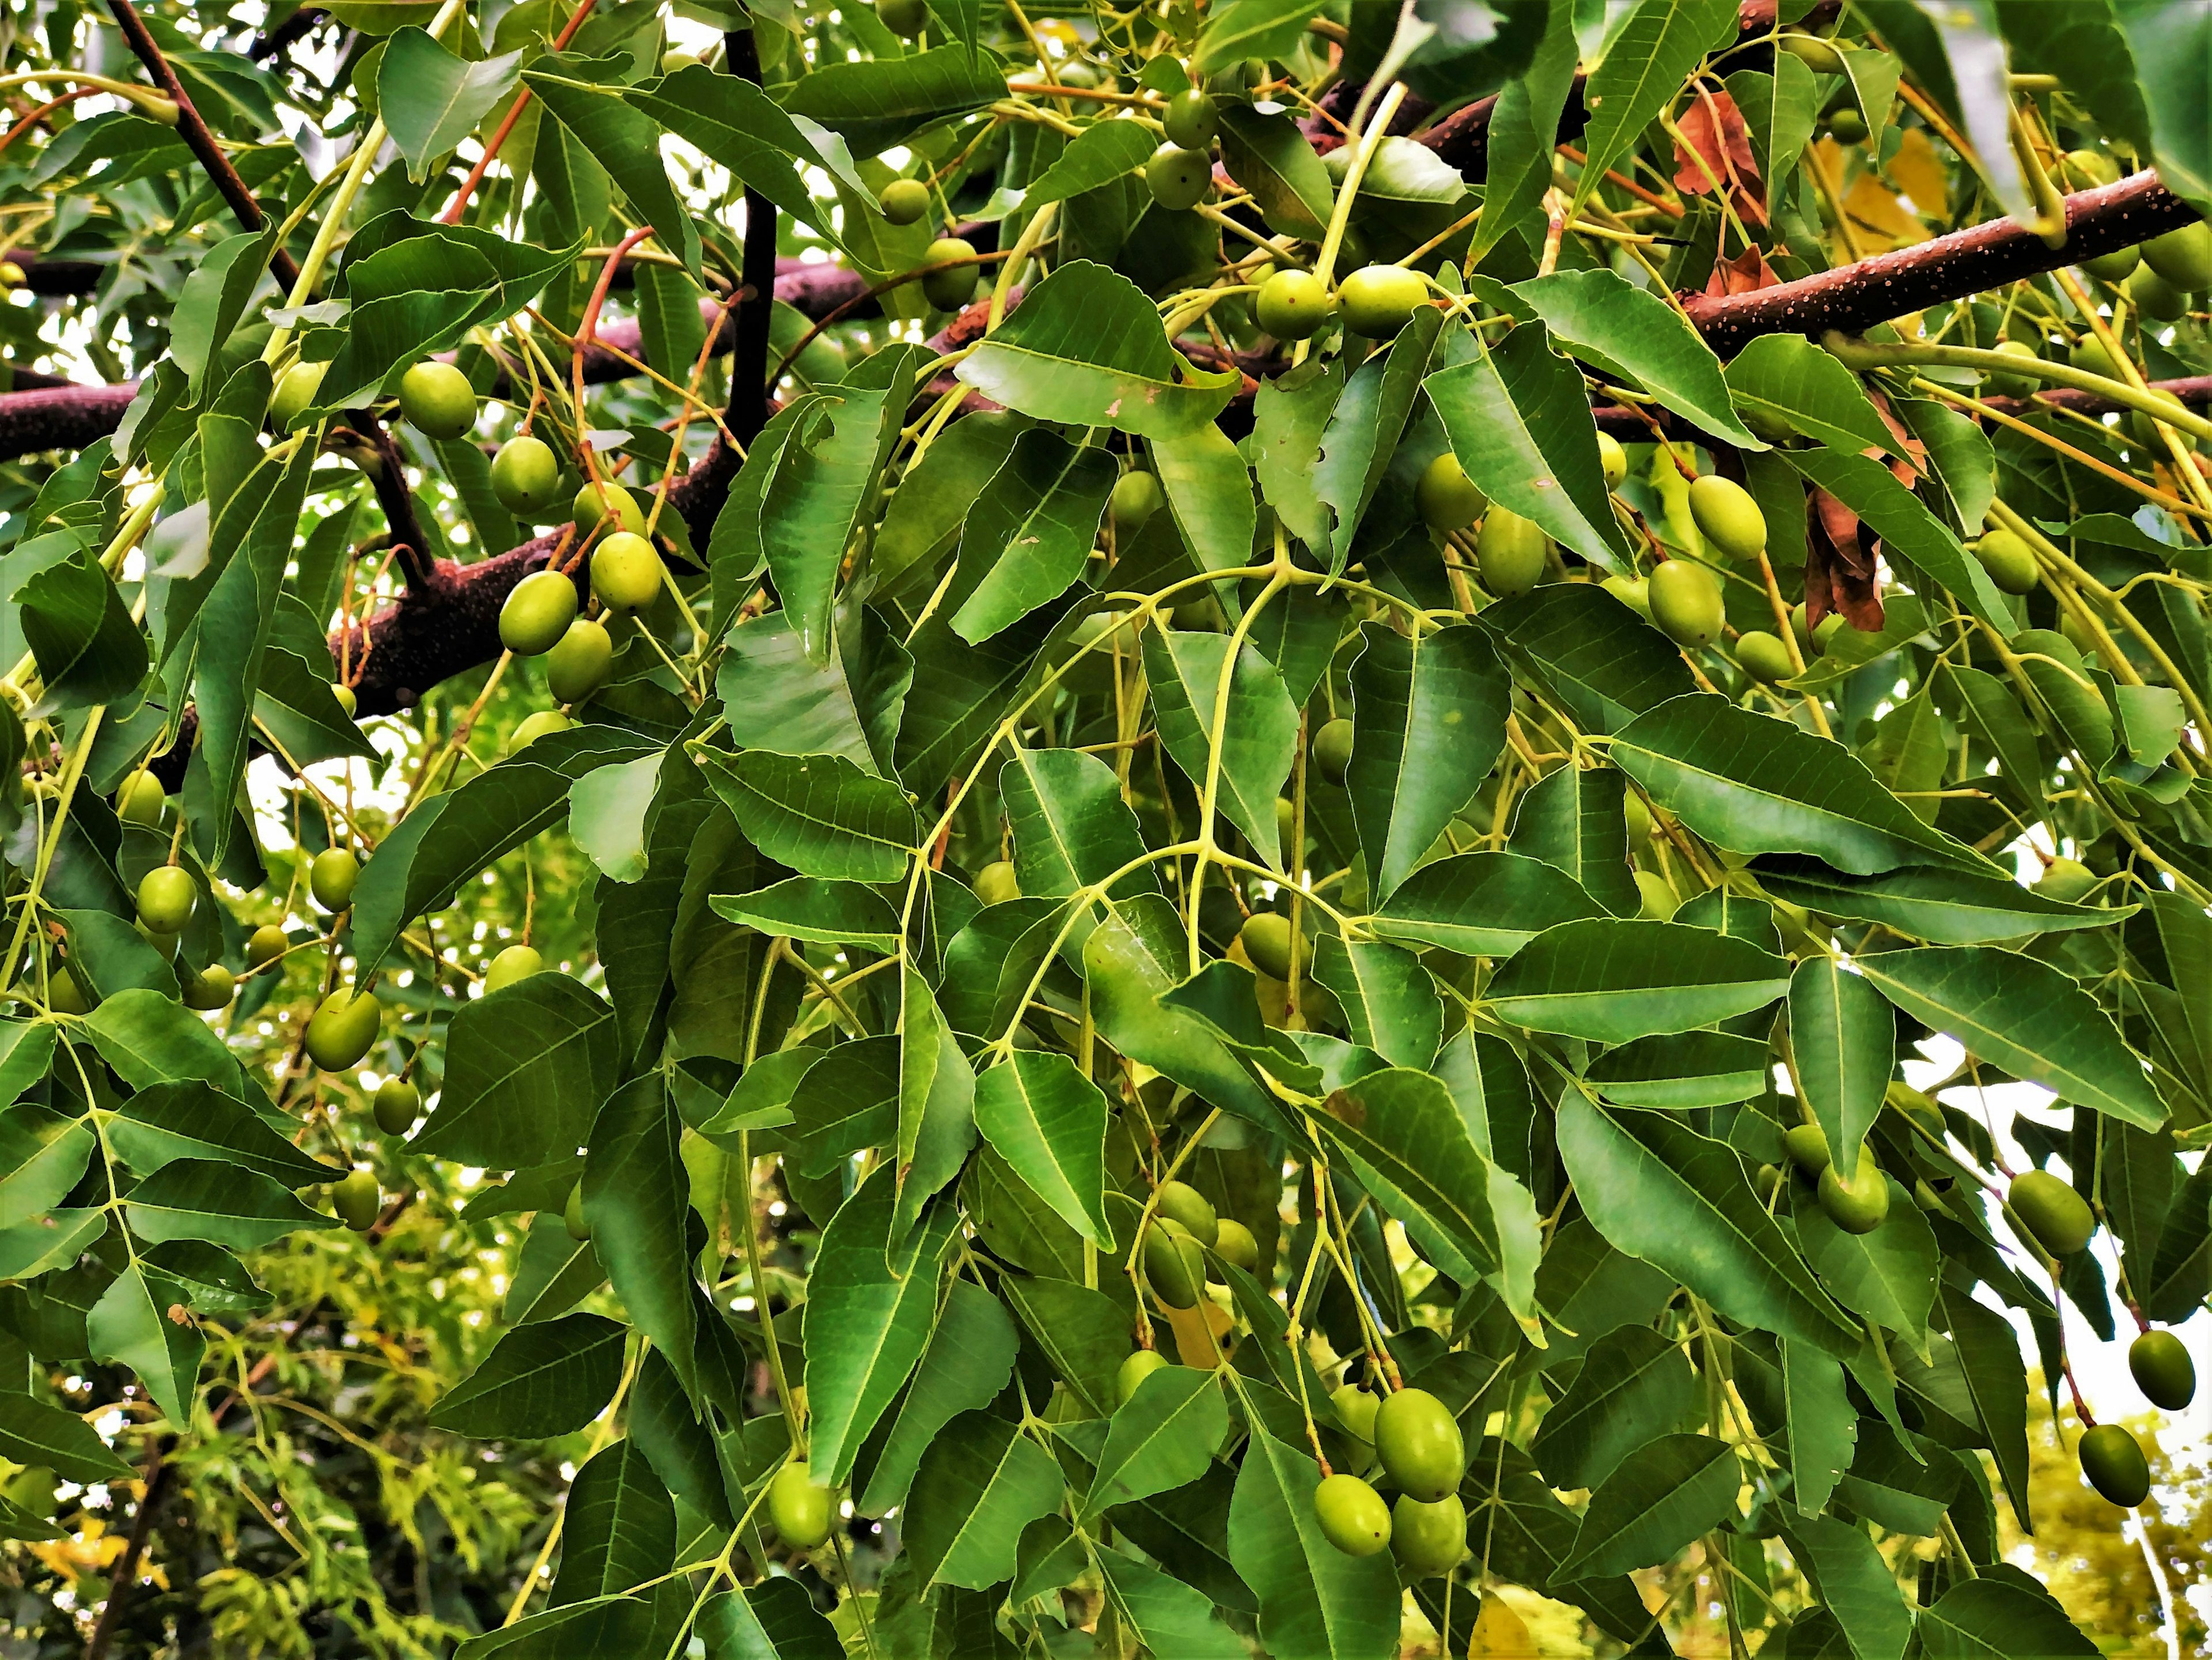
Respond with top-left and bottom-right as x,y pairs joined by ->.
805,1171 -> 960,1479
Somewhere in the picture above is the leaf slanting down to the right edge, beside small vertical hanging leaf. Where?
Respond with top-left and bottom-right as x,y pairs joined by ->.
1858,945 -> 2165,1129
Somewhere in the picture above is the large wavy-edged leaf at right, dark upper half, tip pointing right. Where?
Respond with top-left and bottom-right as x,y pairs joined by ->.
1611,693 -> 1991,876
